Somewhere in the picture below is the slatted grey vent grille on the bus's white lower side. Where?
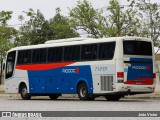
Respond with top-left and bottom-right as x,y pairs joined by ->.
101,76 -> 113,91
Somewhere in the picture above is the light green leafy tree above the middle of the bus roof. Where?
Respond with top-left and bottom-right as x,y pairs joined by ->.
69,0 -> 104,38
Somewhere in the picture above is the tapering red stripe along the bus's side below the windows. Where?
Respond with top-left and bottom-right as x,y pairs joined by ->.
16,62 -> 75,70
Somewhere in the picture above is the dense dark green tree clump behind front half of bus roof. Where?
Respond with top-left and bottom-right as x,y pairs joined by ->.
15,9 -> 79,46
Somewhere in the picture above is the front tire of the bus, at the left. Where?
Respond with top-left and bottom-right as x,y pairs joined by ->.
20,84 -> 31,100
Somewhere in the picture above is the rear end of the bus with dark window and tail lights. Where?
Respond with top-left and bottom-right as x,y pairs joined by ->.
117,38 -> 155,94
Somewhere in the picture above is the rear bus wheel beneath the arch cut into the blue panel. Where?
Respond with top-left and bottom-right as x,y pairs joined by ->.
77,83 -> 90,100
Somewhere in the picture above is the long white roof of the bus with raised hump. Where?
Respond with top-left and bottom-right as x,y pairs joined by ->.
9,36 -> 151,51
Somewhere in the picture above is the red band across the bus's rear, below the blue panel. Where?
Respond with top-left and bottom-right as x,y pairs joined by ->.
124,78 -> 153,85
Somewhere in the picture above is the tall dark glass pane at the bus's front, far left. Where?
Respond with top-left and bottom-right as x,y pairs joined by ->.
5,51 -> 16,79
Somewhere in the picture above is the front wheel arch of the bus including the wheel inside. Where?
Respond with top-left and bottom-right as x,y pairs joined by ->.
18,82 -> 31,100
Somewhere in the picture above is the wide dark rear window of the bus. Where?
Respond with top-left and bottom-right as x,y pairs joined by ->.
123,40 -> 152,56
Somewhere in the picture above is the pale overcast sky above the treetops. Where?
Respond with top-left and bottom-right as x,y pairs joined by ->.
0,0 -> 159,27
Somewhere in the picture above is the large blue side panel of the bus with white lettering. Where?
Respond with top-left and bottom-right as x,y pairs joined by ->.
28,65 -> 93,94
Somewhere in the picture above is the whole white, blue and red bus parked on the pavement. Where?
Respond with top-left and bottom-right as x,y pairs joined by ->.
5,37 -> 155,101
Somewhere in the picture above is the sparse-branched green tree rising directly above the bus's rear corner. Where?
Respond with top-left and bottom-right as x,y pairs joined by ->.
106,0 -> 140,37
